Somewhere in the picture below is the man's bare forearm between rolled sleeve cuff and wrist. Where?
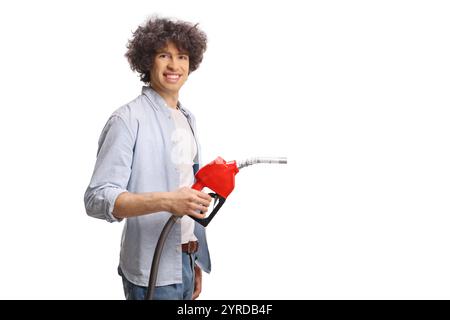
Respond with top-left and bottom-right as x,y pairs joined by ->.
113,192 -> 169,218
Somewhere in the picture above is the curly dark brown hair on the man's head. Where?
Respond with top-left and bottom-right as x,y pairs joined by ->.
125,17 -> 207,83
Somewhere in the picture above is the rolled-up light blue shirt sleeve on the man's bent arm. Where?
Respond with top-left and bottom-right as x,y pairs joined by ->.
84,115 -> 135,222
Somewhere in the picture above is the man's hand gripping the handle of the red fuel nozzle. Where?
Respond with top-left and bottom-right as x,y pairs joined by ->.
168,187 -> 212,219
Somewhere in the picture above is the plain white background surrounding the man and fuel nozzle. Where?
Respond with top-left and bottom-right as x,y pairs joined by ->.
0,0 -> 450,299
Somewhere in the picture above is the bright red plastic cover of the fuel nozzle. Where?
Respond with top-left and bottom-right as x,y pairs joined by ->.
192,157 -> 239,198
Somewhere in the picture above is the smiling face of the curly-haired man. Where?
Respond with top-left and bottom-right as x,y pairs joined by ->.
150,42 -> 189,96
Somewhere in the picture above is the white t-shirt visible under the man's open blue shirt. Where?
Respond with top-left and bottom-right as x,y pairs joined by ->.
169,108 -> 197,243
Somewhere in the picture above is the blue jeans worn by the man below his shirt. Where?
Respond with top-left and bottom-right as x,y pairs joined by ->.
119,252 -> 195,300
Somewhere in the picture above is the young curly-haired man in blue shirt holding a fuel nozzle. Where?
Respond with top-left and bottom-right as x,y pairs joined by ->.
84,18 -> 211,299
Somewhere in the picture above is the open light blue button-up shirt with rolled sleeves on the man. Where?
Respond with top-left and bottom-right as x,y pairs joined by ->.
84,87 -> 211,286
